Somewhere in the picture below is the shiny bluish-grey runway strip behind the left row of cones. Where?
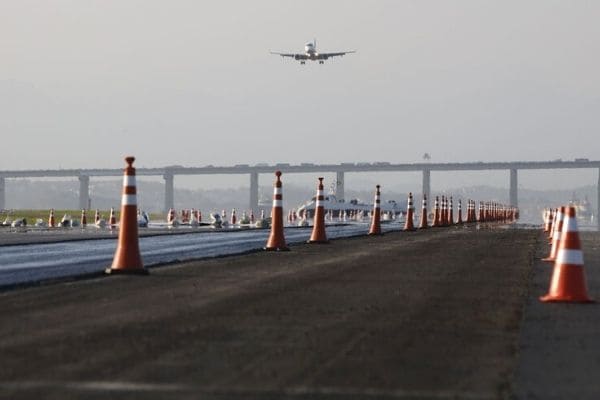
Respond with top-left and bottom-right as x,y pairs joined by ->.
0,223 -> 402,287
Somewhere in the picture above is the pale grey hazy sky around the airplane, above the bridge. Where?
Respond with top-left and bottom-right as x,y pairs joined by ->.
0,0 -> 600,191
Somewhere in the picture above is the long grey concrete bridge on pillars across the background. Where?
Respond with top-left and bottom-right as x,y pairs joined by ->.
0,159 -> 600,226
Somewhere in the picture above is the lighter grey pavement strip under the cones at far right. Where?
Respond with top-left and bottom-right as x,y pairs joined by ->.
514,232 -> 600,400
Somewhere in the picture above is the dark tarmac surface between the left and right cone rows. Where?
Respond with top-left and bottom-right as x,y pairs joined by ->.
0,227 -> 600,399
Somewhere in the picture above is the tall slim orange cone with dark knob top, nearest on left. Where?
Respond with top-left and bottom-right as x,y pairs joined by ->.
105,157 -> 148,274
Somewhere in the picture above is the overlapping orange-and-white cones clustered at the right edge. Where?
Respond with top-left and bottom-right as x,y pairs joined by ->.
540,206 -> 594,303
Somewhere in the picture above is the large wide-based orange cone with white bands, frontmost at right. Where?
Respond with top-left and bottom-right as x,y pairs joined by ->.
540,206 -> 594,303
